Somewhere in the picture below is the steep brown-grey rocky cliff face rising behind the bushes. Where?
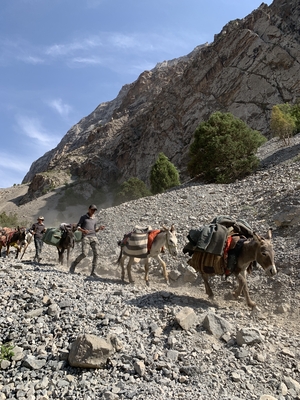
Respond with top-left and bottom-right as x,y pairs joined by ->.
23,0 -> 300,194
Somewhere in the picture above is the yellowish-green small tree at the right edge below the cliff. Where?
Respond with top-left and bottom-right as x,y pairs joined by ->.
270,103 -> 300,145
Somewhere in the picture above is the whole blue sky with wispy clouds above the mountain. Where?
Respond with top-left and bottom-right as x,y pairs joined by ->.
0,0 -> 271,188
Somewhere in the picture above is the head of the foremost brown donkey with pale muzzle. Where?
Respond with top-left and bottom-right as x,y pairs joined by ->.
253,229 -> 277,276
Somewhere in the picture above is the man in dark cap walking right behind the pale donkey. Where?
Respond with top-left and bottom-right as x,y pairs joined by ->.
69,204 -> 104,276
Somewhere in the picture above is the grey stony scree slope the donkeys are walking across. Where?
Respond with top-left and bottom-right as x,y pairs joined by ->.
0,135 -> 300,400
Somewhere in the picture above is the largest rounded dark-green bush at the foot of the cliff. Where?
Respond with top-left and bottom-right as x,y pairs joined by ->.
188,111 -> 267,183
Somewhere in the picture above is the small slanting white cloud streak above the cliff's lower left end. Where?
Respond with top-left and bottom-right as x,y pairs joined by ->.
17,116 -> 58,150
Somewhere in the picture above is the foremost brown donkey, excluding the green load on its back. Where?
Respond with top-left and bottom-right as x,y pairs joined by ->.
188,229 -> 277,309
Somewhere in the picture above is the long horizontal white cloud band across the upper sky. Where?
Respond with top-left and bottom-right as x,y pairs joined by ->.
0,31 -> 207,71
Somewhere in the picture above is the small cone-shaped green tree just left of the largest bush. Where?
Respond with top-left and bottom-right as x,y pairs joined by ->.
150,153 -> 180,194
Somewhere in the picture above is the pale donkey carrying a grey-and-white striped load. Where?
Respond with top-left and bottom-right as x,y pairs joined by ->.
118,225 -> 178,285
